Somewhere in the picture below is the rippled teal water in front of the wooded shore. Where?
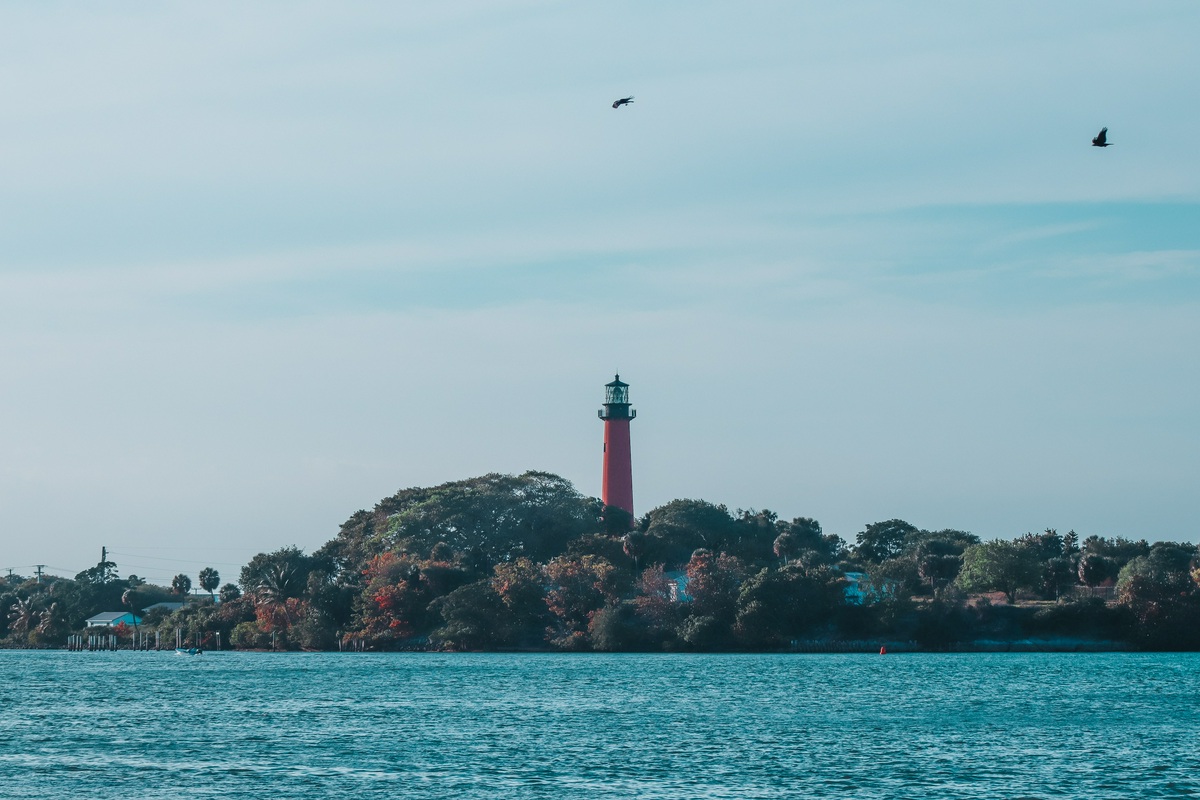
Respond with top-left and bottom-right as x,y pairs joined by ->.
0,651 -> 1200,800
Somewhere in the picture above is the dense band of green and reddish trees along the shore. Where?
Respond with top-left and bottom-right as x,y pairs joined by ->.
7,471 -> 1200,651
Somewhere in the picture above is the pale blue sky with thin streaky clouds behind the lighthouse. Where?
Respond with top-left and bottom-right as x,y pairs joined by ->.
0,0 -> 1200,583
